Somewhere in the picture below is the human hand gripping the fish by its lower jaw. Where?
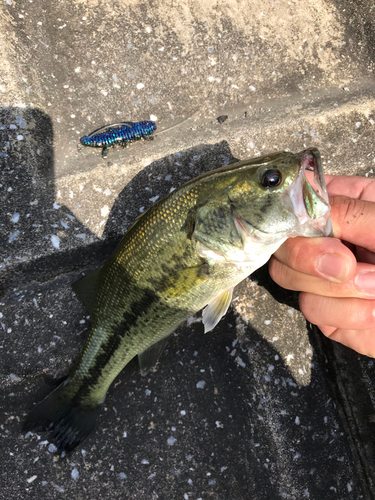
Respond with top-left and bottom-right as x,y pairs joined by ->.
269,176 -> 375,357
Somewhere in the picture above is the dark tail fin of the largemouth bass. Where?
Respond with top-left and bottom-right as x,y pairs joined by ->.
22,381 -> 103,451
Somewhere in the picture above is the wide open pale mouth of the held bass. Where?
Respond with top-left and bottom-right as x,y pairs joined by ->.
289,148 -> 333,236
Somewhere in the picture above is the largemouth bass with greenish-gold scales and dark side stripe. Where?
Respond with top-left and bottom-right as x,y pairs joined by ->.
24,149 -> 331,451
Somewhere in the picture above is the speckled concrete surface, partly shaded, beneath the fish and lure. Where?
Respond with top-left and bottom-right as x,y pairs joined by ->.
0,0 -> 375,500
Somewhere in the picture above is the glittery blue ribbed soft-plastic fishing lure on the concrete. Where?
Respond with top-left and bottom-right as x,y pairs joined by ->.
80,121 -> 156,158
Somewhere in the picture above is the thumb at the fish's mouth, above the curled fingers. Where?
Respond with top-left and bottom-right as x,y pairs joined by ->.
329,196 -> 375,252
